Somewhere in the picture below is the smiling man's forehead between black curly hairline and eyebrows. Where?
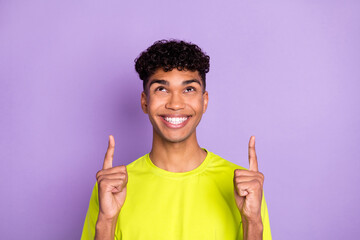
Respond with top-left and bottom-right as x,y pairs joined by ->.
149,68 -> 201,85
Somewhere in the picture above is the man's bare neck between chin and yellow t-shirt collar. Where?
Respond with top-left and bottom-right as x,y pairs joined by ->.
149,131 -> 206,172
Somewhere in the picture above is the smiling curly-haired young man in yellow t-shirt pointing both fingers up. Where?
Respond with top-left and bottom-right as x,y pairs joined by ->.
82,40 -> 271,240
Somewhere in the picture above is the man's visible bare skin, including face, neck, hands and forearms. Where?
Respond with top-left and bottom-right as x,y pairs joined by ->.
95,69 -> 264,240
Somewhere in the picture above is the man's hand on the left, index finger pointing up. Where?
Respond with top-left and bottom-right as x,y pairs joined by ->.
96,135 -> 128,220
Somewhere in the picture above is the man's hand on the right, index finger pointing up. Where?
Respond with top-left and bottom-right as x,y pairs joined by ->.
234,136 -> 264,223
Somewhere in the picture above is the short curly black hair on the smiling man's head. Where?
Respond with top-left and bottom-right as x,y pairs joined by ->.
135,40 -> 210,92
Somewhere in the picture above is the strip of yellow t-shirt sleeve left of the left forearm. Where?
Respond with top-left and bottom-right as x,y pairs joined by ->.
81,183 -> 99,240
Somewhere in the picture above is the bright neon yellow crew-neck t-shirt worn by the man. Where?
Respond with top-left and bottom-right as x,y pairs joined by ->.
81,151 -> 271,240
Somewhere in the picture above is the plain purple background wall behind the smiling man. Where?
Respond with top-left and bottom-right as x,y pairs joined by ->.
0,0 -> 360,240
